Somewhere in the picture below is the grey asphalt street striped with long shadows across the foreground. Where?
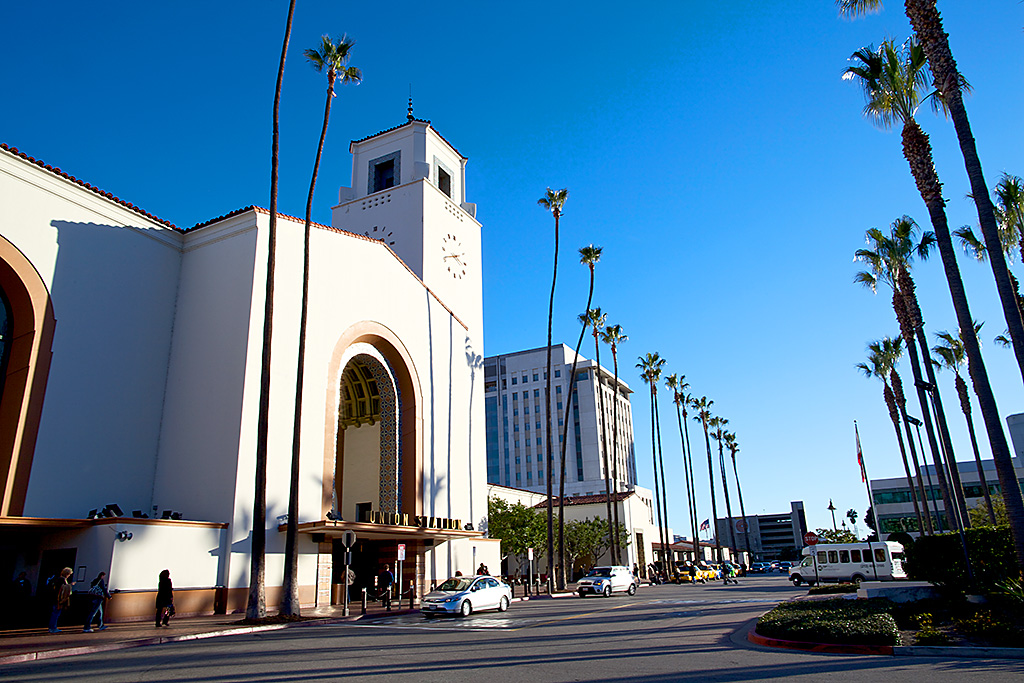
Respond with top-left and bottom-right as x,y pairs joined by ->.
0,575 -> 1024,683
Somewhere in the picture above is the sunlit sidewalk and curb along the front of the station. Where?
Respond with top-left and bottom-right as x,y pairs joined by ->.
0,601 -> 418,665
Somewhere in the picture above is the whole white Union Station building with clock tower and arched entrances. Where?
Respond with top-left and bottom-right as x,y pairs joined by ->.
0,115 -> 500,620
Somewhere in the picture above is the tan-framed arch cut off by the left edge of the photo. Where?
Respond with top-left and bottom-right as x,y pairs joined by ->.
0,238 -> 54,516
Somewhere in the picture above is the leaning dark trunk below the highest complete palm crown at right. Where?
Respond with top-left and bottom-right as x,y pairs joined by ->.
903,118 -> 1024,567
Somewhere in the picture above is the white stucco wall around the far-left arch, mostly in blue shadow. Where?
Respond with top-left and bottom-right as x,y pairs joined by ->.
0,151 -> 181,517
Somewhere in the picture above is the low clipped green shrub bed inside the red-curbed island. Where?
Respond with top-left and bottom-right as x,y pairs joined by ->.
757,599 -> 900,645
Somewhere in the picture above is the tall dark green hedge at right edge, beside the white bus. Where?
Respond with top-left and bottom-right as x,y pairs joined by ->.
906,526 -> 1020,591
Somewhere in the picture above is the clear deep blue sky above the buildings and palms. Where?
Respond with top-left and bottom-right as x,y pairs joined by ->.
0,0 -> 1024,532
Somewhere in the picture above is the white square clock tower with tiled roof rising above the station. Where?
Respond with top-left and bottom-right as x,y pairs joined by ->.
332,111 -> 482,331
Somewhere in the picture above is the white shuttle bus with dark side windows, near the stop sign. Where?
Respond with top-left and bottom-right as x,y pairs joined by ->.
790,541 -> 906,586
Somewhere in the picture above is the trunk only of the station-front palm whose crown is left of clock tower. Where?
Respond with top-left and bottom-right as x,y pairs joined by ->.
281,65 -> 334,616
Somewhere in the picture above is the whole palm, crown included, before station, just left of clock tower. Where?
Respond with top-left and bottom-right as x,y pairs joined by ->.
281,36 -> 362,616
